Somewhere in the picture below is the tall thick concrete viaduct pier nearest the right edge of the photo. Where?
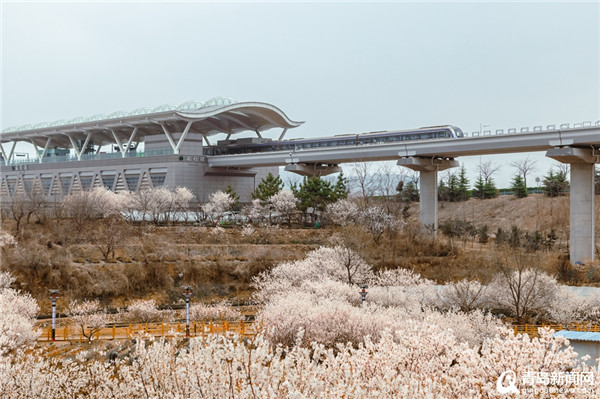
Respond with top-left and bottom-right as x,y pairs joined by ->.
546,147 -> 598,263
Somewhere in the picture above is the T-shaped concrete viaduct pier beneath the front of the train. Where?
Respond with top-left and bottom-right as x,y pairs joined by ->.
398,157 -> 459,235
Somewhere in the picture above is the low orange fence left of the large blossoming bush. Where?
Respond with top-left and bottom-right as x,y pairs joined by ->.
38,321 -> 256,341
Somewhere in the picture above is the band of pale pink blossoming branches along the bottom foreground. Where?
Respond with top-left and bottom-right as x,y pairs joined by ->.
0,323 -> 600,399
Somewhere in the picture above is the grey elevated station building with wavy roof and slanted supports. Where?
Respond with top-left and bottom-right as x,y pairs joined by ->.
0,97 -> 303,202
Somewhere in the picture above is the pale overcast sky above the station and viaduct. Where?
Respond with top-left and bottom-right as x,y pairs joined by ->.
1,1 -> 600,185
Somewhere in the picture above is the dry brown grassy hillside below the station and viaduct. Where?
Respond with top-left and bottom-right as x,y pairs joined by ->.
0,195 -> 600,307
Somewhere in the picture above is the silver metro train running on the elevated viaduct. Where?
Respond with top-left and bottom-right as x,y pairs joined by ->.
204,125 -> 464,155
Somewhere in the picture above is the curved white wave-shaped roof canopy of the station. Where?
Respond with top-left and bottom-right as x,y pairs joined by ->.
0,97 -> 304,148
